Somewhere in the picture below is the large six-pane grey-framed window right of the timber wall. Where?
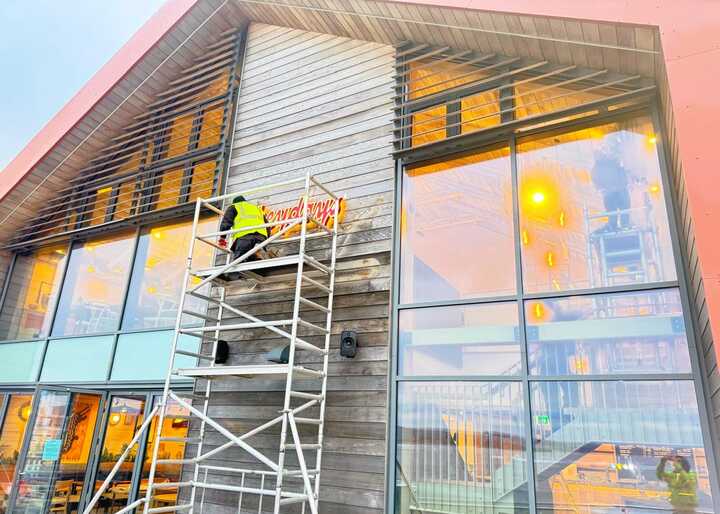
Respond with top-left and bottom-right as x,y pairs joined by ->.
389,112 -> 715,514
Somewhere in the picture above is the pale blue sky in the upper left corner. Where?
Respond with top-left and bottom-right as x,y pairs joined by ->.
0,0 -> 164,172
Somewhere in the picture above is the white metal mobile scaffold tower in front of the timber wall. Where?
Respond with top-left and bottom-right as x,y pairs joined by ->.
84,173 -> 341,514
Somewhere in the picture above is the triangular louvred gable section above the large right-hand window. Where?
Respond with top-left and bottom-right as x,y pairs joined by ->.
394,43 -> 655,153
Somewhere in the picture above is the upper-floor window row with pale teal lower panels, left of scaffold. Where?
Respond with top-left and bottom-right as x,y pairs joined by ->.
0,217 -> 213,384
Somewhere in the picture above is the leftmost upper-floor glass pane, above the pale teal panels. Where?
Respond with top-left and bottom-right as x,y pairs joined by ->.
0,245 -> 67,340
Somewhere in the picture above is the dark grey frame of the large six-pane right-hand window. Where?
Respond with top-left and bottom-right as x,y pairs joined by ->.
385,102 -> 720,514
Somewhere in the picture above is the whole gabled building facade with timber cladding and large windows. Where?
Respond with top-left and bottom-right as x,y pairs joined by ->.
0,0 -> 720,514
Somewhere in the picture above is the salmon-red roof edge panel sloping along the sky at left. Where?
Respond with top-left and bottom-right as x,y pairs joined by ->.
0,0 -> 198,201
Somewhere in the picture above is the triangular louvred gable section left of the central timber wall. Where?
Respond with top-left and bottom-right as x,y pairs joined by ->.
9,29 -> 244,246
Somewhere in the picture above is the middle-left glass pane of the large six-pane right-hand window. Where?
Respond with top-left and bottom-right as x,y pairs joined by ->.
398,303 -> 521,376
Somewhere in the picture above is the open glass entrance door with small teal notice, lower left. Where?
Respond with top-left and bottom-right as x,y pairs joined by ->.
10,388 -> 103,514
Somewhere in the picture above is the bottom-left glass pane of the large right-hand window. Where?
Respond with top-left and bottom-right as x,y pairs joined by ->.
395,382 -> 528,514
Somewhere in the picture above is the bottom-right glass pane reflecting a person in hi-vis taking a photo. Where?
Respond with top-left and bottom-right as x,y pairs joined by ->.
532,381 -> 713,514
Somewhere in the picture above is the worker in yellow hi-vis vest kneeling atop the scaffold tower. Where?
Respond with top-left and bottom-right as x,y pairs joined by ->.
218,195 -> 268,261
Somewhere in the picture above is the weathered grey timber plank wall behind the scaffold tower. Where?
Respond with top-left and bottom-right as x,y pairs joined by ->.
181,24 -> 394,514
